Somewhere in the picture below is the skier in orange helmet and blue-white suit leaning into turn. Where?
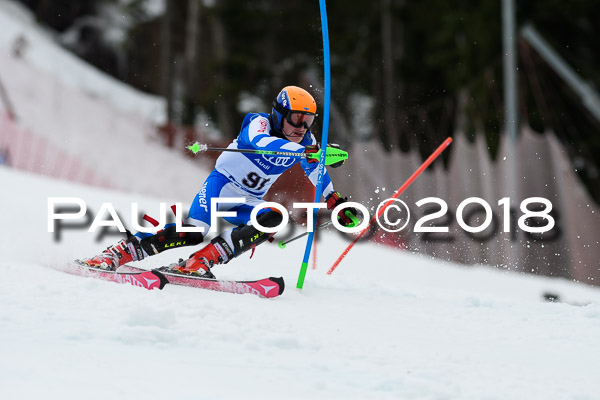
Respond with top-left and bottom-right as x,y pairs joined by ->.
83,86 -> 357,278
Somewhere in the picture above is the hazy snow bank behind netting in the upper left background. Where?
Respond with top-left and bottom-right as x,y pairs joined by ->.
0,0 -> 212,198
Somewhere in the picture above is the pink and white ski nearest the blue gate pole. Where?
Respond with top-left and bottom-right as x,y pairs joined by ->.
120,265 -> 285,298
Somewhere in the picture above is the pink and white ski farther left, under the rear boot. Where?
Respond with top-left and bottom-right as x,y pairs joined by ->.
66,261 -> 169,290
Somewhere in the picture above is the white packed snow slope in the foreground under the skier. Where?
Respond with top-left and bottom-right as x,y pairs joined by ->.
0,167 -> 600,400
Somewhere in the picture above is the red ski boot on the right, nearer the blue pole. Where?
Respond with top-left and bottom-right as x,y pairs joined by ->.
173,236 -> 234,279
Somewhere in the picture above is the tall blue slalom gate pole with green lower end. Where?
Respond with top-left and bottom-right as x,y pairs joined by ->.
296,0 -> 331,289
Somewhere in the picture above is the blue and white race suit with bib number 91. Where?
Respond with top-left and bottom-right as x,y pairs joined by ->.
185,113 -> 333,233
